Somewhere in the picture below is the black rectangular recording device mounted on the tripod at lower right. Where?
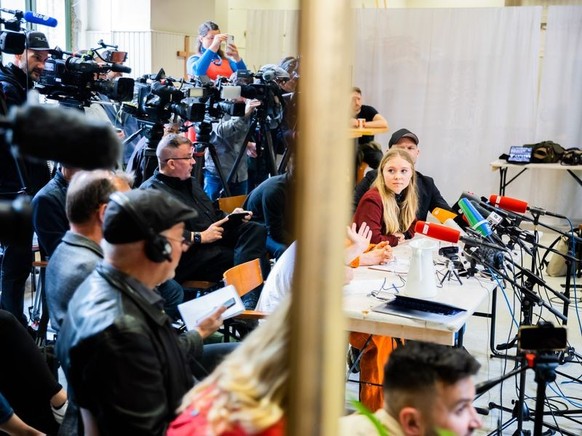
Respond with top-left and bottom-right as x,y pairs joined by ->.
517,322 -> 568,353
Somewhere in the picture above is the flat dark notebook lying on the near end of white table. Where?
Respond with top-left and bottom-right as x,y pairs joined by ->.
372,295 -> 466,323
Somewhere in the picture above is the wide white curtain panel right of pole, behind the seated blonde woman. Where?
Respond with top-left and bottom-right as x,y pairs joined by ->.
353,7 -> 541,215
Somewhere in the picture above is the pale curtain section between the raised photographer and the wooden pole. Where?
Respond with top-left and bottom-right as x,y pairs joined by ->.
245,10 -> 299,71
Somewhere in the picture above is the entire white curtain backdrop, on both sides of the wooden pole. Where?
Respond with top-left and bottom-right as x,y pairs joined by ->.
245,6 -> 582,220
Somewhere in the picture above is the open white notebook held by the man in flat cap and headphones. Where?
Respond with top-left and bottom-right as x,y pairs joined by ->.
178,285 -> 245,330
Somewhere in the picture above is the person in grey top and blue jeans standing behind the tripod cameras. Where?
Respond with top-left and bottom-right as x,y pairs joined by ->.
204,99 -> 261,201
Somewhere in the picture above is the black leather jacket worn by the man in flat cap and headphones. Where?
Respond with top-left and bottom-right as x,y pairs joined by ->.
57,263 -> 202,435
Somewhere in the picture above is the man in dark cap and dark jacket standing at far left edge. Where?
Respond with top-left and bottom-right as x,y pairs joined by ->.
0,32 -> 51,325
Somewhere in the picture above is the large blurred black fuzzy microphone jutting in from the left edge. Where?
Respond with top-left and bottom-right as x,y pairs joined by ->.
5,104 -> 121,170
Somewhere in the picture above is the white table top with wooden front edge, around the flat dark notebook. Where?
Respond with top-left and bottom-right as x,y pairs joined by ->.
344,242 -> 495,345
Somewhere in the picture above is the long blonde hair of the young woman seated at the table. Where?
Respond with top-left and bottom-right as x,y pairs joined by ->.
374,148 -> 418,235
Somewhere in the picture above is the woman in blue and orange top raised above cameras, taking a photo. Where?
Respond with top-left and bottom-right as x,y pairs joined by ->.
187,21 -> 247,80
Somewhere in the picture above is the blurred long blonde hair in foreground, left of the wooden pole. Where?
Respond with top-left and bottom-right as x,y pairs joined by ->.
179,296 -> 291,434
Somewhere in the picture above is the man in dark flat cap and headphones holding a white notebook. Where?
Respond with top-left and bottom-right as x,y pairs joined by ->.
57,190 -> 229,435
